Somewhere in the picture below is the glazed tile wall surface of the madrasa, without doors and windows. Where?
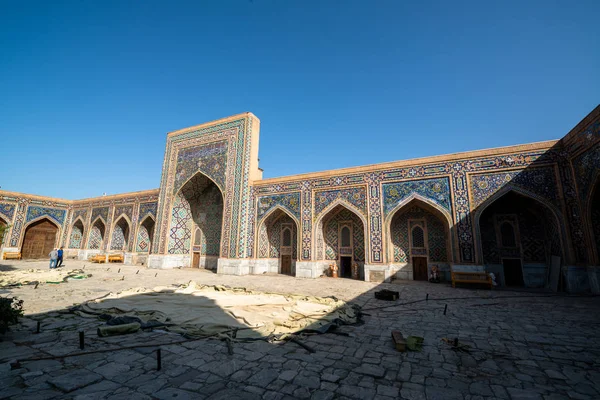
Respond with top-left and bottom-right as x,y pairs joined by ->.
0,108 -> 600,290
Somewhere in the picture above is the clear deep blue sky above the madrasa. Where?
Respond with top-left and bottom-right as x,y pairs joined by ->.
0,0 -> 600,199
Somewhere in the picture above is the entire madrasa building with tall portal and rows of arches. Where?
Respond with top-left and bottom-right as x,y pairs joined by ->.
0,106 -> 600,292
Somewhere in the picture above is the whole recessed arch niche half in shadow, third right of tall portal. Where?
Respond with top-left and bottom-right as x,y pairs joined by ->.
384,193 -> 457,264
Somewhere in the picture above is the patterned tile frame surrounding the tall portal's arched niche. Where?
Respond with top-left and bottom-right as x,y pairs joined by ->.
153,113 -> 259,258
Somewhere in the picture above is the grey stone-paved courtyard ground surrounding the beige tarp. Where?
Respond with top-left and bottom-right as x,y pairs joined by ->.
0,260 -> 600,400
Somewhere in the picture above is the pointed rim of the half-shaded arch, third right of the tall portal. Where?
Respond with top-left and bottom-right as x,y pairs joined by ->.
383,192 -> 458,263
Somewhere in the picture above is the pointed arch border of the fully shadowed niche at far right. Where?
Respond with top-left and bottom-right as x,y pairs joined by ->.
473,184 -> 571,263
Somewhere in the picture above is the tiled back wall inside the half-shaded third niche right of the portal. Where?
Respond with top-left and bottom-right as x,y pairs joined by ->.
390,205 -> 448,263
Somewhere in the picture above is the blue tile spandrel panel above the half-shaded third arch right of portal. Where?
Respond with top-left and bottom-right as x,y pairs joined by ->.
382,178 -> 452,216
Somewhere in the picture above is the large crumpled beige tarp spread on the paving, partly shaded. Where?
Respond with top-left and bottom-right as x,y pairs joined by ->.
77,282 -> 357,337
